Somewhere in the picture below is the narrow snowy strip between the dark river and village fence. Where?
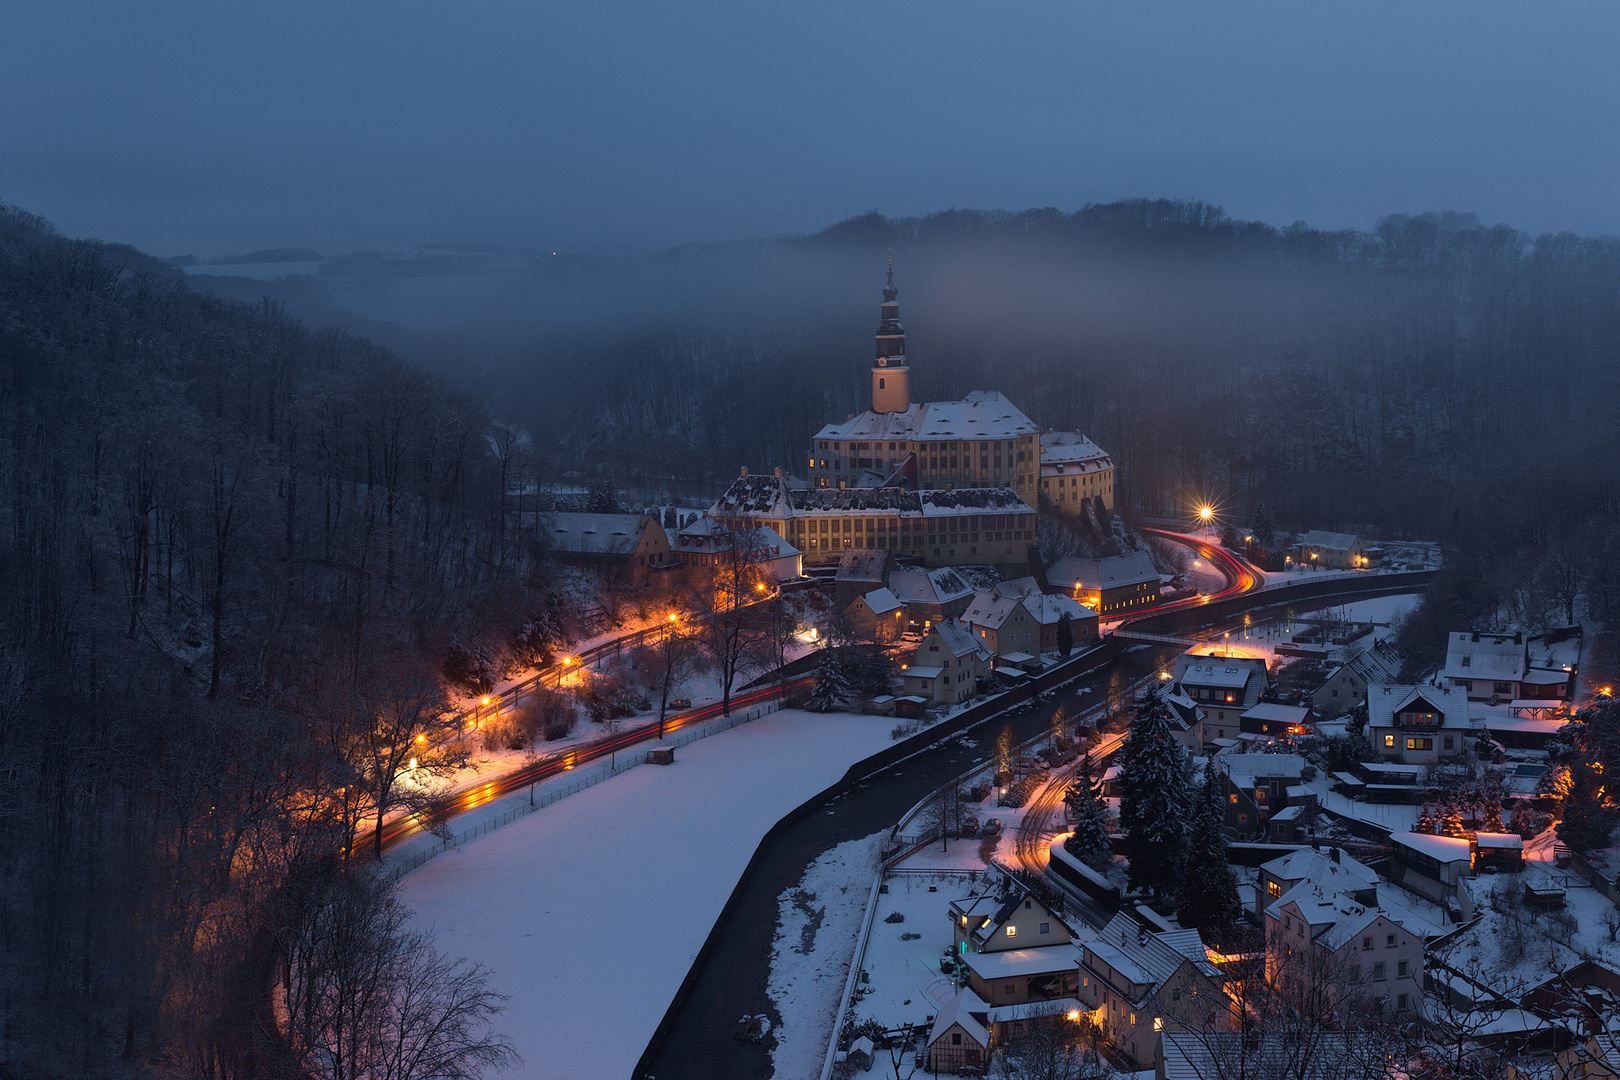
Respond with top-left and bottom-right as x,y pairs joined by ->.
768,831 -> 886,1080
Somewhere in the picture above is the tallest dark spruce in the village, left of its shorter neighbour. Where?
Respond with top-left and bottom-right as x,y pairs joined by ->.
1119,690 -> 1191,895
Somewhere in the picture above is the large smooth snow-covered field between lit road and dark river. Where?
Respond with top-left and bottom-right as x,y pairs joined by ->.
402,711 -> 900,1080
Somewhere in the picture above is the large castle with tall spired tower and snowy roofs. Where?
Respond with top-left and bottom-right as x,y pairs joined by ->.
708,269 -> 1115,575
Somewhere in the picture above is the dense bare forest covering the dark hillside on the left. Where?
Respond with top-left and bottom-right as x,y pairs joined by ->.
0,207 -> 538,1077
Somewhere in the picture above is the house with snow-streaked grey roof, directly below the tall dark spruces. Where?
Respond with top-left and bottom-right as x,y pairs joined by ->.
1077,912 -> 1231,1067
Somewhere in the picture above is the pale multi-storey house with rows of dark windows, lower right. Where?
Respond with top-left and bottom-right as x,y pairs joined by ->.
1264,881 -> 1424,1015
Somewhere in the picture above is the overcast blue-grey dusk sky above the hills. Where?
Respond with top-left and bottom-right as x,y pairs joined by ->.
0,0 -> 1620,256
